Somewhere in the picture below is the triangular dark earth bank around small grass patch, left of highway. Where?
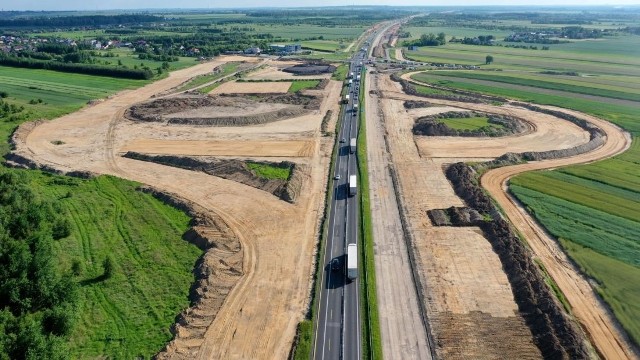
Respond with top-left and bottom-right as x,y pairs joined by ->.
123,152 -> 304,203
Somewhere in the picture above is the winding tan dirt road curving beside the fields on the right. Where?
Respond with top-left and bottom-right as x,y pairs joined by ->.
481,107 -> 637,359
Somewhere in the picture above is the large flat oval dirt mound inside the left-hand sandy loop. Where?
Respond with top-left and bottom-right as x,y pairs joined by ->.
125,94 -> 320,126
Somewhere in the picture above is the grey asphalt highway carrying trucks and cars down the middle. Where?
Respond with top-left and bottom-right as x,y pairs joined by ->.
313,35 -> 374,359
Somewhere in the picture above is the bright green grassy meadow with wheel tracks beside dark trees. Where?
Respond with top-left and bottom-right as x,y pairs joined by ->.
25,171 -> 202,359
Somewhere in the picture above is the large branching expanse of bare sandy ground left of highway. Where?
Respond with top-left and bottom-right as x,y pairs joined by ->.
16,58 -> 340,359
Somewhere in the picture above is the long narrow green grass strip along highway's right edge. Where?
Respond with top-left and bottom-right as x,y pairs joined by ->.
356,71 -> 382,359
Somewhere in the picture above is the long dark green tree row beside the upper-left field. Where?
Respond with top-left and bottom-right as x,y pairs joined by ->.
0,54 -> 153,80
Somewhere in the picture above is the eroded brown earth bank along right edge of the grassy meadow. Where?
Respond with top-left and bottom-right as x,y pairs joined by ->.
139,186 -> 243,359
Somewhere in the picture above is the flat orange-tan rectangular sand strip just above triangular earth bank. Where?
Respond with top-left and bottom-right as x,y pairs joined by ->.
120,139 -> 315,157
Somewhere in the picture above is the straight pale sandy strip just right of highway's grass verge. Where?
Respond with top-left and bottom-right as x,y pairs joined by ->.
365,69 -> 431,359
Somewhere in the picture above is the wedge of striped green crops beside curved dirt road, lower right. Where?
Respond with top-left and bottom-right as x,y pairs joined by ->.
510,186 -> 640,342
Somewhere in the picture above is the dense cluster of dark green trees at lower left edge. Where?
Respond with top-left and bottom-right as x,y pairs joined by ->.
0,171 -> 77,359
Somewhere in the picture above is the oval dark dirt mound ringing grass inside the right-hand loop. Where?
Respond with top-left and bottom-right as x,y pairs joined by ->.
412,110 -> 532,137
